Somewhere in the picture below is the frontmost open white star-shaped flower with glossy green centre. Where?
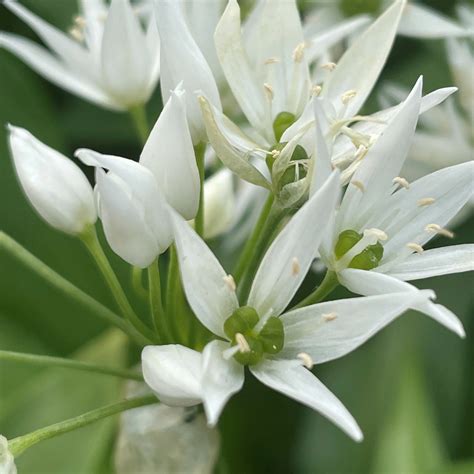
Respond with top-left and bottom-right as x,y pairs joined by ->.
142,173 -> 436,441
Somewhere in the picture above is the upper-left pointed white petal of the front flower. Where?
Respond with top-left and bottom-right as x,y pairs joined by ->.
173,214 -> 239,338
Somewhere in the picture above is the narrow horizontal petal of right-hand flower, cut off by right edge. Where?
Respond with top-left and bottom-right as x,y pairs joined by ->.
377,244 -> 474,281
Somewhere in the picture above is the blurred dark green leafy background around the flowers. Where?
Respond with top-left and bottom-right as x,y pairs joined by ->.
0,0 -> 474,474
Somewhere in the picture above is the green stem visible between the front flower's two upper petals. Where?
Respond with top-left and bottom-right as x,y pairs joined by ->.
239,202 -> 283,303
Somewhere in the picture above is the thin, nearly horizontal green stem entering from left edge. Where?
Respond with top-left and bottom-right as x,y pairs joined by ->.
0,351 -> 143,382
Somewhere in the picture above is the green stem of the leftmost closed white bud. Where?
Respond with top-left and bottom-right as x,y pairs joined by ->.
81,226 -> 153,339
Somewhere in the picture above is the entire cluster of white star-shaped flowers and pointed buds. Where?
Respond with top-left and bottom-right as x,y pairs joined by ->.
0,0 -> 474,472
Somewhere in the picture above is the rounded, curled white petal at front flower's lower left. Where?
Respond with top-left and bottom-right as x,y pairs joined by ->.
142,344 -> 202,406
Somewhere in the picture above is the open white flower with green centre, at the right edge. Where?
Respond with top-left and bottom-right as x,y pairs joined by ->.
320,79 -> 474,336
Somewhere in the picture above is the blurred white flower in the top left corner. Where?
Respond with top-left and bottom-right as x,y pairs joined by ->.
0,0 -> 160,110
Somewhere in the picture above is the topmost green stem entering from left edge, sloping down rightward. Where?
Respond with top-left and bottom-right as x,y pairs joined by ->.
0,232 -> 150,346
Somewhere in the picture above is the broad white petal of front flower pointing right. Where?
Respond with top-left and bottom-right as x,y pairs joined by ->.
278,291 -> 426,364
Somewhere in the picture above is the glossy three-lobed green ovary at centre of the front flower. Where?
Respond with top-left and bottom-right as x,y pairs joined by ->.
224,306 -> 285,365
